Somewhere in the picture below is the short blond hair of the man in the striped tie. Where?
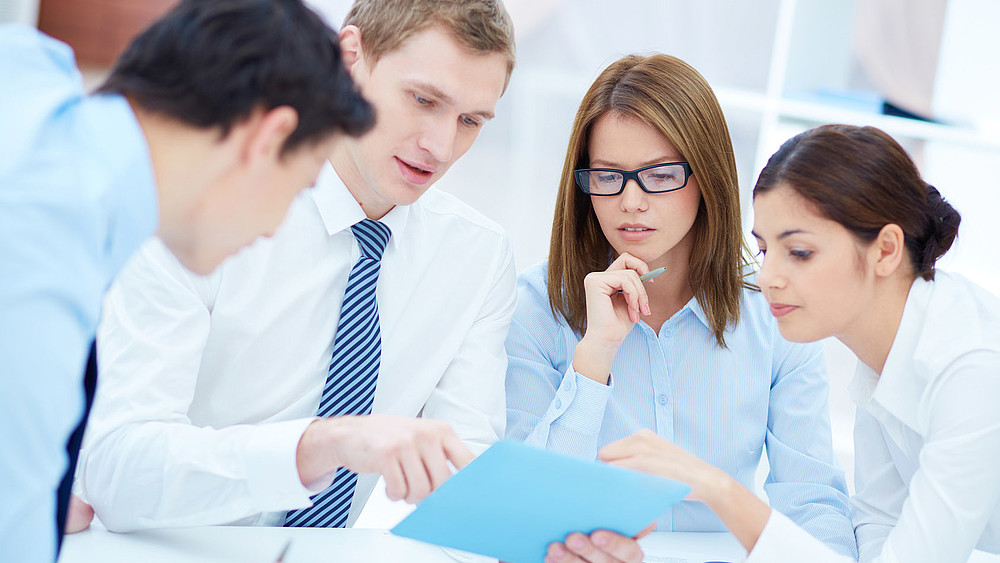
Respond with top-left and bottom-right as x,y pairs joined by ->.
344,0 -> 516,88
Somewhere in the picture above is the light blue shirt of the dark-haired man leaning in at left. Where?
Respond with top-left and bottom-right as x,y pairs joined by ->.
0,25 -> 158,563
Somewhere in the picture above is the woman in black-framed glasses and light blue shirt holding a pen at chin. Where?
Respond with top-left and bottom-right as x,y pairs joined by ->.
506,55 -> 856,563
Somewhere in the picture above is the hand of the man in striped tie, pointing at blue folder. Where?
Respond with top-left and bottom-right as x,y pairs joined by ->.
296,414 -> 475,504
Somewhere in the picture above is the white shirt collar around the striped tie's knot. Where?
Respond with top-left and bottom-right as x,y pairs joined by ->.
311,162 -> 408,249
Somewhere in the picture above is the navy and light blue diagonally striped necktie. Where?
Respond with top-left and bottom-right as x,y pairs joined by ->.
285,219 -> 391,528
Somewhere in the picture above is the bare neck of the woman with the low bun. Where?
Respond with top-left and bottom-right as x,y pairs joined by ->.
837,275 -> 913,375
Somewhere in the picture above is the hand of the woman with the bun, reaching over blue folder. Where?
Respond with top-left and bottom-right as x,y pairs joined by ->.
597,428 -> 730,502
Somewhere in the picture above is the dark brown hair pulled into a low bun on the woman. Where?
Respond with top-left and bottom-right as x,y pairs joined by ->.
753,125 -> 962,280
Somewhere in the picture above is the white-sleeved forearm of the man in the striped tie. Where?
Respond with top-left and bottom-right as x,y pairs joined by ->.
79,419 -> 310,531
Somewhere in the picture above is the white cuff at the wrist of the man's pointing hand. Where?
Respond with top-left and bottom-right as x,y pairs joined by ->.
245,418 -> 324,512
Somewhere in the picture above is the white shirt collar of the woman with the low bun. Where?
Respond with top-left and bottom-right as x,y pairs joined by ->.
849,278 -> 934,434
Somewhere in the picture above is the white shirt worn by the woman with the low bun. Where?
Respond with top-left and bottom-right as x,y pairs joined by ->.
747,271 -> 1000,563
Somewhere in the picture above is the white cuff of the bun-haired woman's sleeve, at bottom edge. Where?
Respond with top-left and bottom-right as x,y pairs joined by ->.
746,508 -> 855,563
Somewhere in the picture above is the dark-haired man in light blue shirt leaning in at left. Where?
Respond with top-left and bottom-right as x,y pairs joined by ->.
0,0 -> 373,562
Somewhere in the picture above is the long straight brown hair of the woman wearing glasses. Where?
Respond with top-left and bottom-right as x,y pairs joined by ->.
548,54 -> 752,347
